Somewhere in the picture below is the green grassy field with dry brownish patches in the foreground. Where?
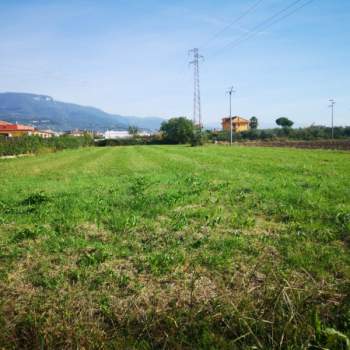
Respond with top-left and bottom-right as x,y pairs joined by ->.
0,146 -> 350,349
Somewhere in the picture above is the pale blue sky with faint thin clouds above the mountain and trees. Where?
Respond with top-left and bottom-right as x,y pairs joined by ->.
0,0 -> 350,127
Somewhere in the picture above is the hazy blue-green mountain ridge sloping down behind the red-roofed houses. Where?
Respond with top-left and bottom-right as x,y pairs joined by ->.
0,92 -> 164,131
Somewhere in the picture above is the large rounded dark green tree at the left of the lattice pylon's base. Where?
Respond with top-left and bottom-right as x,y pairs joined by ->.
160,117 -> 195,144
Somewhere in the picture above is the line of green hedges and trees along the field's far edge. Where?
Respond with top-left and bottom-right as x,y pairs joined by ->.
0,117 -> 350,156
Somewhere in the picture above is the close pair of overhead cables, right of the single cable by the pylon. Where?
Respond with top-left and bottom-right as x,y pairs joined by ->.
212,0 -> 314,57
